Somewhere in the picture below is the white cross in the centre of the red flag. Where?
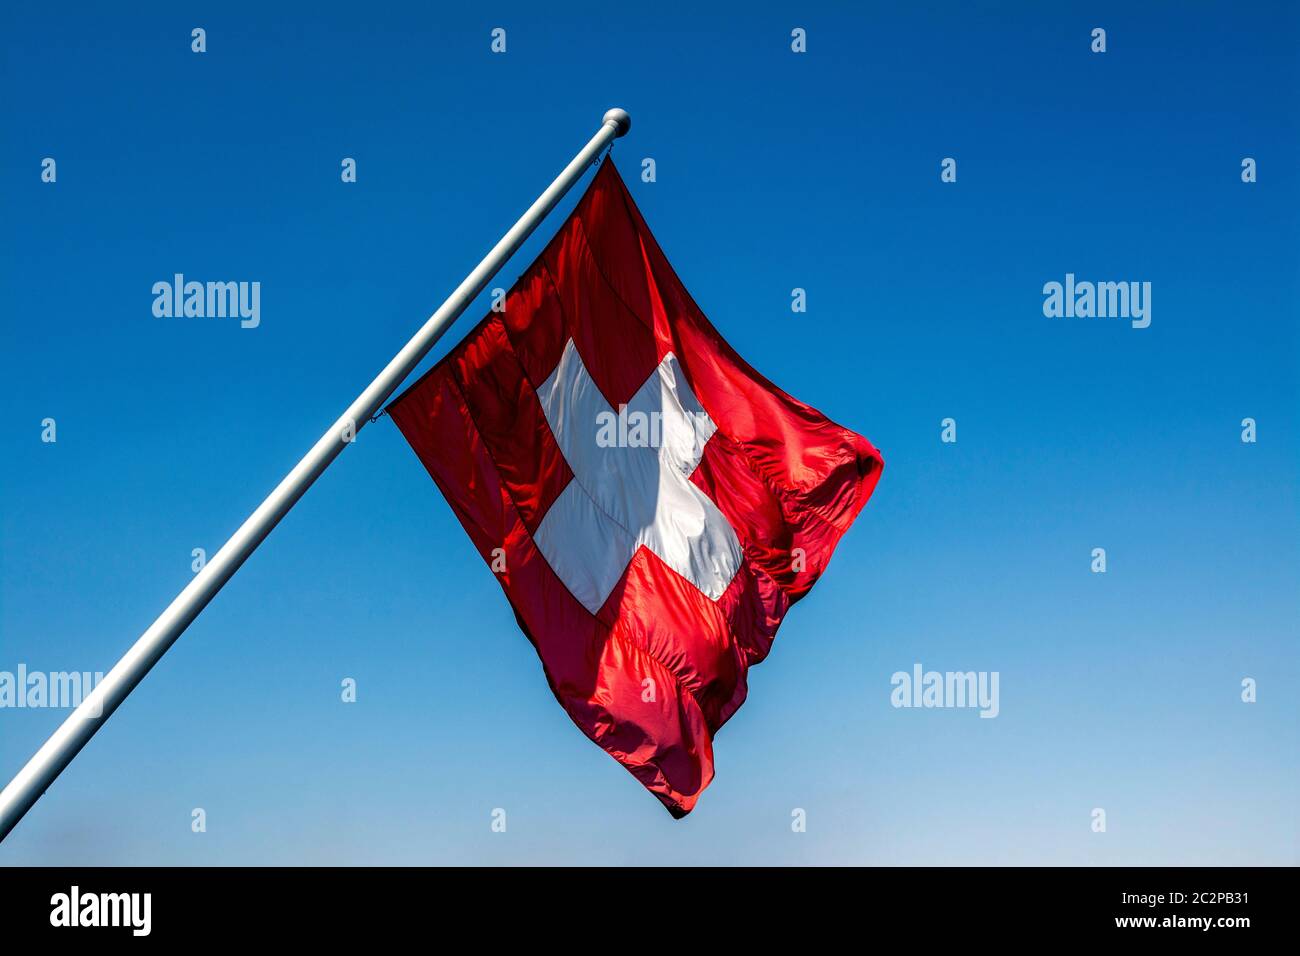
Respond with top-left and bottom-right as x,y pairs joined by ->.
533,339 -> 741,614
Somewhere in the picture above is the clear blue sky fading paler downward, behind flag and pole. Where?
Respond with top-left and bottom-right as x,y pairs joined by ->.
0,3 -> 1300,864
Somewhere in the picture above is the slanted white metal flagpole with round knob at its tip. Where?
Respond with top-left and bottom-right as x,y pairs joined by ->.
0,109 -> 632,840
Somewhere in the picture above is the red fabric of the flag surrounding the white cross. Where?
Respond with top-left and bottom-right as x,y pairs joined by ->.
389,160 -> 883,817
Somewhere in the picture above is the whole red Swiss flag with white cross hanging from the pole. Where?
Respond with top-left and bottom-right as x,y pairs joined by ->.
389,159 -> 883,817
